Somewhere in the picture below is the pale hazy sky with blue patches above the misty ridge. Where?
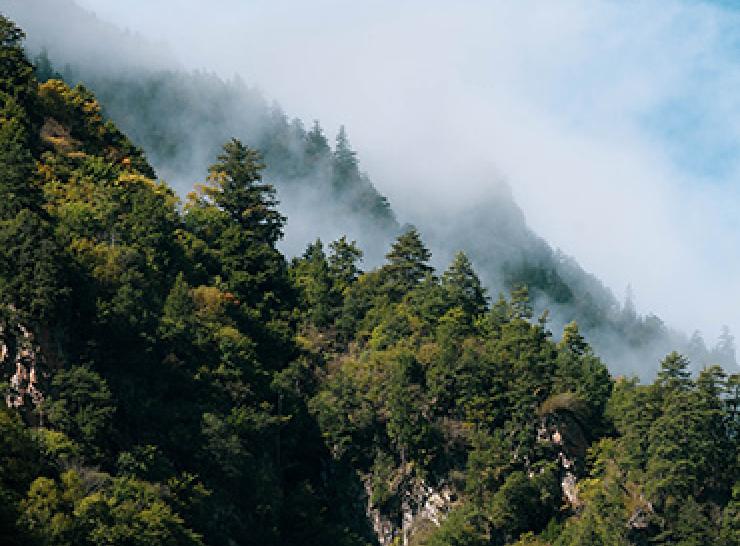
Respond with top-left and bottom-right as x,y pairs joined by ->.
40,0 -> 740,341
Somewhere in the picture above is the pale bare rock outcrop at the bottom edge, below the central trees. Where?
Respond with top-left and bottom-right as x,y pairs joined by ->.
365,472 -> 457,546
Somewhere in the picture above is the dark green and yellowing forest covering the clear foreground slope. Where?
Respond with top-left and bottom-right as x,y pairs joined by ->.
0,17 -> 740,546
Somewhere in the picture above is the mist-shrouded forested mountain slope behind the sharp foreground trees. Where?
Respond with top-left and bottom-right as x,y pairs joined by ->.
7,0 -> 735,379
